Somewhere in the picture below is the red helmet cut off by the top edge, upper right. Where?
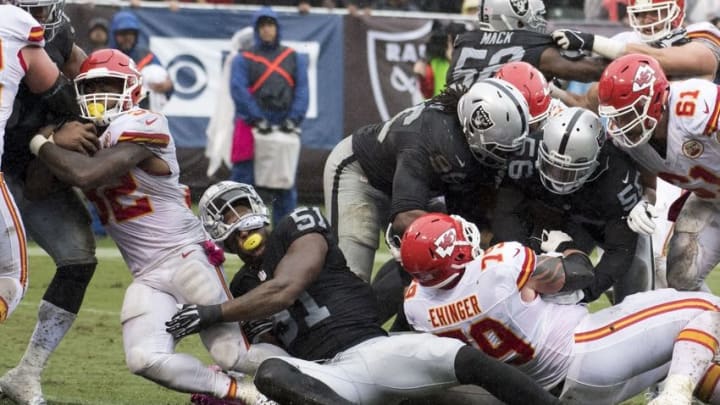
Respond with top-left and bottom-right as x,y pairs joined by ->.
627,0 -> 685,42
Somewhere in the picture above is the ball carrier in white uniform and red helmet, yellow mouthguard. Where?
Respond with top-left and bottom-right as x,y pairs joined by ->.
25,49 -> 284,401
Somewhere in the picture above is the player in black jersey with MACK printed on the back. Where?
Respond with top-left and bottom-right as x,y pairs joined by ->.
447,0 -> 607,86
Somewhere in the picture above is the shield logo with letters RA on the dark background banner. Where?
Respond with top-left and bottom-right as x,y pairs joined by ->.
367,21 -> 432,121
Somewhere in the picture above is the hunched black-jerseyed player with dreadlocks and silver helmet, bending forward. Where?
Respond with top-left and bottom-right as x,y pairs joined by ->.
323,79 -> 528,281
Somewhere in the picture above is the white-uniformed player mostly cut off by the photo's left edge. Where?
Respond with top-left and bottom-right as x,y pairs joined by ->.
0,4 -> 77,322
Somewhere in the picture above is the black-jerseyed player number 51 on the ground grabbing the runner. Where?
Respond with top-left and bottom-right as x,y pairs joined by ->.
167,181 -> 557,405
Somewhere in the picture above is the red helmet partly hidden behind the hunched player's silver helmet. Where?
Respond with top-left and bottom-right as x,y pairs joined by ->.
495,61 -> 552,124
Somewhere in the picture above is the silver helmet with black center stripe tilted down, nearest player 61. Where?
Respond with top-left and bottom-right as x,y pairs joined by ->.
537,107 -> 605,194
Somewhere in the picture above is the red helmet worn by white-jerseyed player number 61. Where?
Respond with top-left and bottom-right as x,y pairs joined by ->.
598,54 -> 670,148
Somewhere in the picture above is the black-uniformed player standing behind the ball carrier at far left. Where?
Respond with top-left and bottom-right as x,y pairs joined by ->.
0,0 -> 97,403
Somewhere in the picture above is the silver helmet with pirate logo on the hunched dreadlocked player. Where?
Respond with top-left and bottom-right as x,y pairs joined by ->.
457,79 -> 529,167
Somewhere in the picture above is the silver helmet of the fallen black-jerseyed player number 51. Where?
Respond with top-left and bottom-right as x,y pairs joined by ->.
198,181 -> 270,242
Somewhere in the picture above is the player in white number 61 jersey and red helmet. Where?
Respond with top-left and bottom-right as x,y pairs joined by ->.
599,54 -> 720,290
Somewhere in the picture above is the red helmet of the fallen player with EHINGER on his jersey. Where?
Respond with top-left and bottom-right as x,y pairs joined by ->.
400,213 -> 481,288
